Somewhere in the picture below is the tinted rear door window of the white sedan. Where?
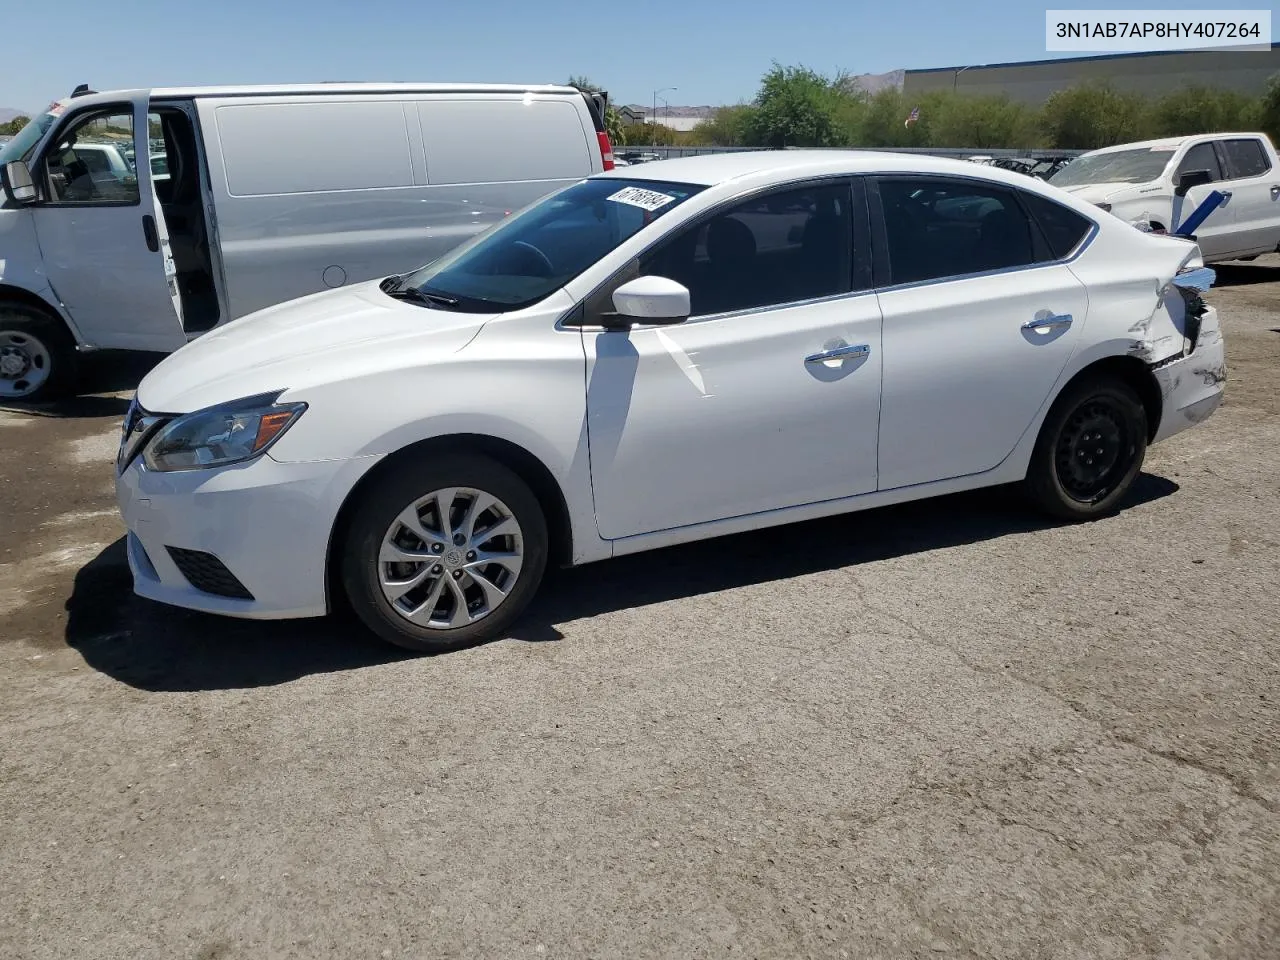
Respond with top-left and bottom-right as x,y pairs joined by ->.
879,178 -> 1036,283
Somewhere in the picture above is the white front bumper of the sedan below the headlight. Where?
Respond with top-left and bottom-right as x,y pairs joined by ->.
115,453 -> 381,620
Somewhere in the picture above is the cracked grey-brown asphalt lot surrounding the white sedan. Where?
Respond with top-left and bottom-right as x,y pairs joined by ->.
0,256 -> 1280,960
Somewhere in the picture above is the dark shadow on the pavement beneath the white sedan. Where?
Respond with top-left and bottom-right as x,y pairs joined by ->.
65,474 -> 1178,691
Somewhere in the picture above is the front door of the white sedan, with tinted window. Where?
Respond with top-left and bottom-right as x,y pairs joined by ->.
584,182 -> 881,540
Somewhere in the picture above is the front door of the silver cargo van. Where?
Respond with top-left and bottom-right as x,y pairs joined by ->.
31,92 -> 187,352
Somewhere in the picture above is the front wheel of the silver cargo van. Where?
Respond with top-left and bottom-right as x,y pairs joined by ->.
0,303 -> 77,403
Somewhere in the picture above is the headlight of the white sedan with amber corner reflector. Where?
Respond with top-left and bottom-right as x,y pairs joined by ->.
142,390 -> 307,472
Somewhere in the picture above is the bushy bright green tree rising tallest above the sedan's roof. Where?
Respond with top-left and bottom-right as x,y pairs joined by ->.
744,63 -> 849,147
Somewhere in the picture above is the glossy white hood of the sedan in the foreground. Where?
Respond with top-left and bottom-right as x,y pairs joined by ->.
137,280 -> 495,413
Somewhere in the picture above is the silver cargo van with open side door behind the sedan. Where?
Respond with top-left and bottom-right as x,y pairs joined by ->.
0,83 -> 613,402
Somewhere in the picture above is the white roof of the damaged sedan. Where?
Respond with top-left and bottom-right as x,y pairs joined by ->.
596,150 -> 1054,187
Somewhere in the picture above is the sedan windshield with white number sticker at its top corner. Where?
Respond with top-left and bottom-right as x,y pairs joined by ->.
388,178 -> 704,312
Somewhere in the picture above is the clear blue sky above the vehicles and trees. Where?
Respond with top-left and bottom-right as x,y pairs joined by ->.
0,0 -> 1267,110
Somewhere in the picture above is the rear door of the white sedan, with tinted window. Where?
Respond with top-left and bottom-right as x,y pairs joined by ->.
877,177 -> 1091,490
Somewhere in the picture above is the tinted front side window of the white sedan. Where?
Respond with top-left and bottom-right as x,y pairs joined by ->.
640,184 -> 852,316
